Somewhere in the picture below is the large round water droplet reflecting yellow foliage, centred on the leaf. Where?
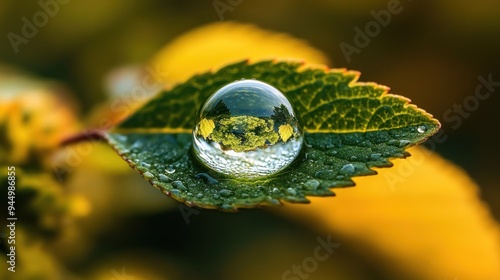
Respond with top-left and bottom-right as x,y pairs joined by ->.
193,80 -> 304,178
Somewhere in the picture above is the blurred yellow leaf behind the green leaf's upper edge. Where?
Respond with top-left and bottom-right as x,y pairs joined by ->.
150,22 -> 328,83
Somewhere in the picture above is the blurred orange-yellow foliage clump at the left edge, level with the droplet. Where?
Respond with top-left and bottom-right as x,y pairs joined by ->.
0,79 -> 79,164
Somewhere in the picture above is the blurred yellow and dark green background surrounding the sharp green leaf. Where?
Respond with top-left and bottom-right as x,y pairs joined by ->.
0,0 -> 500,280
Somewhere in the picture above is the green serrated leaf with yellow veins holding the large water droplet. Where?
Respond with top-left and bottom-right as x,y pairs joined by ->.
106,61 -> 440,211
